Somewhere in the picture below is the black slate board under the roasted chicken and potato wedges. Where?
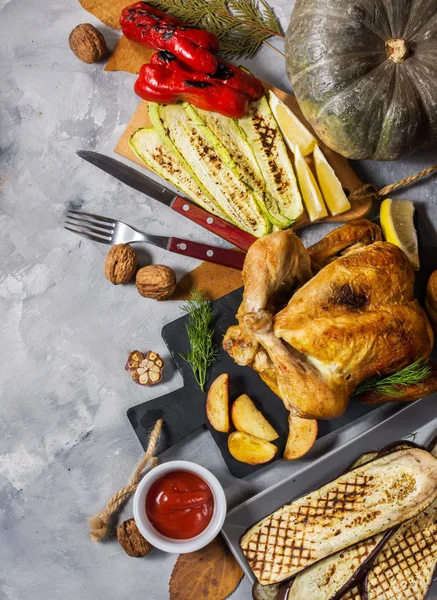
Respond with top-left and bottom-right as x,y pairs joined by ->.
127,214 -> 437,477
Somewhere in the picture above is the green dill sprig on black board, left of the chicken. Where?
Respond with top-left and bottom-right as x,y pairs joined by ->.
181,289 -> 218,392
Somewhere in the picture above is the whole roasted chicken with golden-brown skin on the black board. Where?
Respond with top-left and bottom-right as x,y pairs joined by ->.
223,219 -> 437,419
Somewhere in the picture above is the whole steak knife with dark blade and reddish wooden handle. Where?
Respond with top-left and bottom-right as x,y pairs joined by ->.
76,150 -> 256,252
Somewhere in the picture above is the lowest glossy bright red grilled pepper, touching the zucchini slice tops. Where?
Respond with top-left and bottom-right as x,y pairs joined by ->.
135,64 -> 250,119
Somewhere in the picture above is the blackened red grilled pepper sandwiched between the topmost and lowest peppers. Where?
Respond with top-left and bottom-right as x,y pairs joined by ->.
150,51 -> 264,100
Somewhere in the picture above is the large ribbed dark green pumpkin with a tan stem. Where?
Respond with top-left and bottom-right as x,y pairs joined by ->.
285,0 -> 437,160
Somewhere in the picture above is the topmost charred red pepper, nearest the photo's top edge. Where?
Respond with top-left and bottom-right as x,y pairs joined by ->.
120,2 -> 219,73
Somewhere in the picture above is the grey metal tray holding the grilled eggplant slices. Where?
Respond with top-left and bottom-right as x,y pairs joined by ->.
222,393 -> 437,600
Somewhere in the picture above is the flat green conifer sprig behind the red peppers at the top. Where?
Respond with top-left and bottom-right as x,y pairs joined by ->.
149,0 -> 284,58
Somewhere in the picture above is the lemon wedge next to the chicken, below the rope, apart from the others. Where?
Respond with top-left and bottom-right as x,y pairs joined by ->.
380,198 -> 420,271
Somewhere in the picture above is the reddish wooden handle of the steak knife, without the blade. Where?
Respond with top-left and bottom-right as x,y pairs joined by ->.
171,196 -> 256,252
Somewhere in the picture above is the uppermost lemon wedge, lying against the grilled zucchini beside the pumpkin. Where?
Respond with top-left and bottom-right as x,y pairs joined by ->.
268,90 -> 317,156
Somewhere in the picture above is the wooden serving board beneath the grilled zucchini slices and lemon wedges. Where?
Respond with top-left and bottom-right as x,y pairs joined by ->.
114,82 -> 372,229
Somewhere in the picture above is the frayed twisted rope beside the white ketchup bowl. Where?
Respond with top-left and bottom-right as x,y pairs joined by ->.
88,419 -> 164,542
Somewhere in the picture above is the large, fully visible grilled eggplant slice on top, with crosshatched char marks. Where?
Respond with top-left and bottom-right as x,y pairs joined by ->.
240,448 -> 437,585
